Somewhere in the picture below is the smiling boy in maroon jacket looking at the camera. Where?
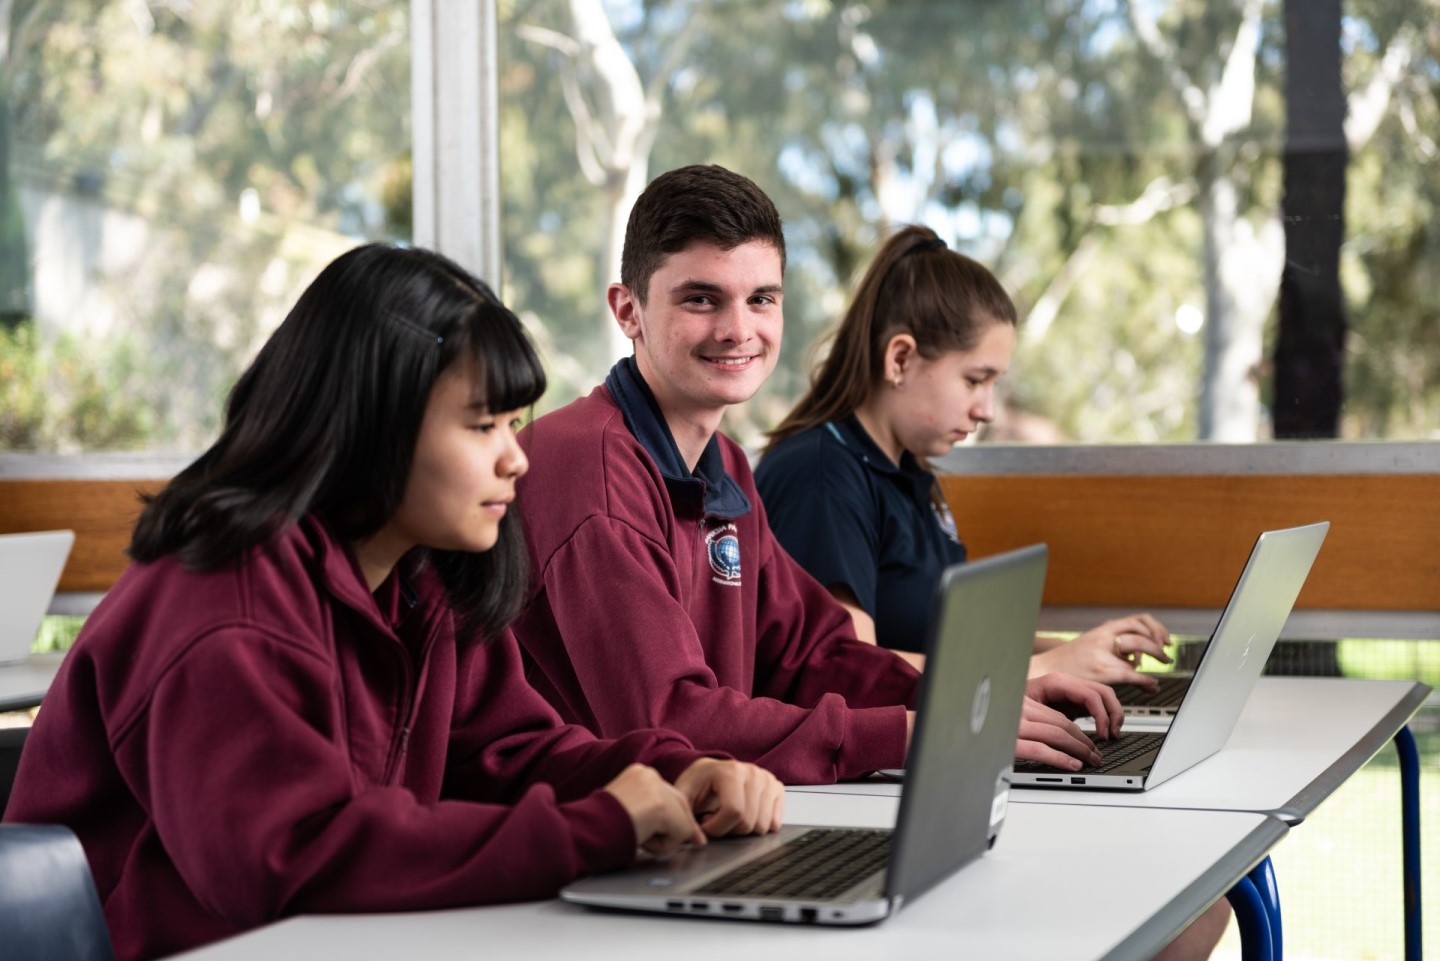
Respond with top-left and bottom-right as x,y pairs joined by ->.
514,166 -> 1119,784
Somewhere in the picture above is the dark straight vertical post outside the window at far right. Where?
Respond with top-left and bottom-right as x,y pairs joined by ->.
1272,0 -> 1348,438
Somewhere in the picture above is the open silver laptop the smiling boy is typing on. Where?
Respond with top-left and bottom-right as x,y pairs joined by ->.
1014,522 -> 1331,791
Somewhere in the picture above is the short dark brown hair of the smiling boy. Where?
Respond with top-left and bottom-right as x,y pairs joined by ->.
621,164 -> 785,304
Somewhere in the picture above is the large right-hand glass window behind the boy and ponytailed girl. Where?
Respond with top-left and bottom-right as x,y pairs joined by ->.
500,0 -> 1440,444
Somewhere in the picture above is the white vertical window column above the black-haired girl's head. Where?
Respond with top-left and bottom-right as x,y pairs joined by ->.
410,0 -> 500,288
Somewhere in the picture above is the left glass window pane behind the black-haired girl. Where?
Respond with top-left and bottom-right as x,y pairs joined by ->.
0,0 -> 410,452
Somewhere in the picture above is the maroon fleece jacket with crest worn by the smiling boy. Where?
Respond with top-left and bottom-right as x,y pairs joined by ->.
514,388 -> 919,784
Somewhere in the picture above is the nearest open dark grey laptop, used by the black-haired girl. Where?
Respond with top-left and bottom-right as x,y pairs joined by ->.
560,545 -> 1048,925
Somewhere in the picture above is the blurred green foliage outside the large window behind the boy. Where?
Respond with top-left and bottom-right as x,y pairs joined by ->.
500,0 -> 1440,441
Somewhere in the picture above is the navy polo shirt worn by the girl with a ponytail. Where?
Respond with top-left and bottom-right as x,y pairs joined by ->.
755,415 -> 965,651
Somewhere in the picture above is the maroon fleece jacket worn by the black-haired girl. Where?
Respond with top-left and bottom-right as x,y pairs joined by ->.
6,519 -> 700,961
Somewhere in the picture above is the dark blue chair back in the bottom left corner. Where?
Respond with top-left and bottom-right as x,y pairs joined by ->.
0,824 -> 115,961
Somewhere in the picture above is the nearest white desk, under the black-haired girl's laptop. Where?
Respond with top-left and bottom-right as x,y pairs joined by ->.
168,792 -> 1286,961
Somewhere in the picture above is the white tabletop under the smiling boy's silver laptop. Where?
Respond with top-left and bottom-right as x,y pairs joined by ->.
799,677 -> 1428,824
